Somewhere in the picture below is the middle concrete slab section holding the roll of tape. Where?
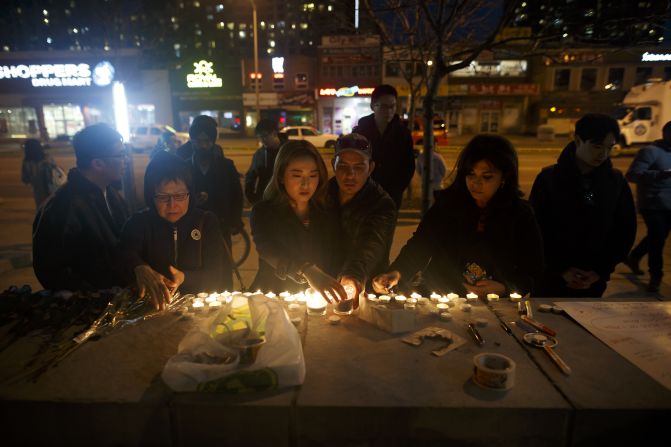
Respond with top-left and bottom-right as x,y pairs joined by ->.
296,303 -> 571,445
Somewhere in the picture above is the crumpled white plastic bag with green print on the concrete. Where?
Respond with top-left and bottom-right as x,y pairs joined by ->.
162,295 -> 305,393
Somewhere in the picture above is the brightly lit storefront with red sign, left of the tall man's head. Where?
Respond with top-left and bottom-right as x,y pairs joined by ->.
317,85 -> 374,135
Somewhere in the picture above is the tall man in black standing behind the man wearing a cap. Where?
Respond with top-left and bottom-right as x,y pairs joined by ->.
354,84 -> 415,209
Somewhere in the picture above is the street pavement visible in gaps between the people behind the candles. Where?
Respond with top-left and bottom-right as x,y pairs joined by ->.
0,137 -> 671,294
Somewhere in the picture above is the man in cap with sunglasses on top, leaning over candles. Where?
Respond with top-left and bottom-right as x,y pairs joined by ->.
327,134 -> 397,296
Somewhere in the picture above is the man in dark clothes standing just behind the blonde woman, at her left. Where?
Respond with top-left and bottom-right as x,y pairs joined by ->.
245,119 -> 282,205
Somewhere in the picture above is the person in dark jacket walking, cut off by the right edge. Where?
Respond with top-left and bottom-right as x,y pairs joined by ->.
626,121 -> 671,293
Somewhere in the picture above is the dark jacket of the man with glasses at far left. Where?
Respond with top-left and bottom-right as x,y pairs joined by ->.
33,168 -> 128,290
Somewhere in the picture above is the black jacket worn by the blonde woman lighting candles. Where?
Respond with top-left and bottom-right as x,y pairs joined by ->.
250,200 -> 342,293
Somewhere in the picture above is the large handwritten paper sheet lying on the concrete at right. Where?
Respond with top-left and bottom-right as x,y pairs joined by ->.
556,301 -> 671,390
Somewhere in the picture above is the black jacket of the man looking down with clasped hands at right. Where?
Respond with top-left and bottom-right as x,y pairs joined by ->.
529,143 -> 636,296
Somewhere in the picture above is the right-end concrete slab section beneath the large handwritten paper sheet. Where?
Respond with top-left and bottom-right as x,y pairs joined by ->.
493,298 -> 671,445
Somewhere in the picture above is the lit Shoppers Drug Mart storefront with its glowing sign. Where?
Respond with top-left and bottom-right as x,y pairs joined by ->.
0,50 -> 172,140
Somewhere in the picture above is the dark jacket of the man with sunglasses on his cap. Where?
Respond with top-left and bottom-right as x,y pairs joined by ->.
328,178 -> 397,284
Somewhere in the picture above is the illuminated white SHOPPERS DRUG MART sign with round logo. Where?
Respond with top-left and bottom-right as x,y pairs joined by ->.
0,61 -> 115,87
